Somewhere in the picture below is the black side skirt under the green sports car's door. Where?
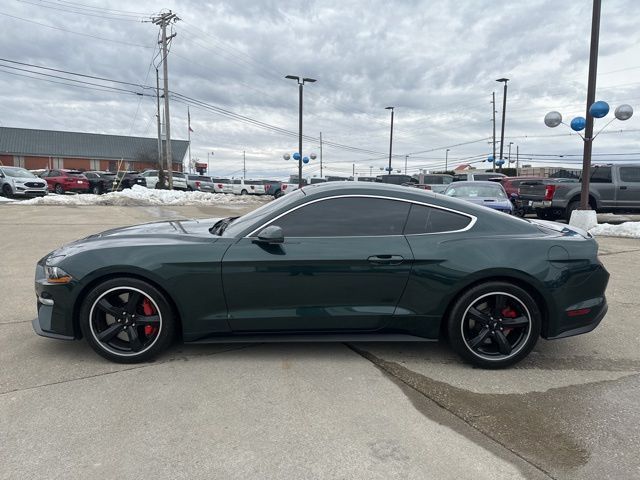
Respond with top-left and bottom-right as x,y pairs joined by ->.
185,333 -> 438,344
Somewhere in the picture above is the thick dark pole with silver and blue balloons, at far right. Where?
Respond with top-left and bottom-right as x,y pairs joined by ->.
580,0 -> 602,210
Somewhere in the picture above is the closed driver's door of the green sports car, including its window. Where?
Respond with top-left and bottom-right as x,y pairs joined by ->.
222,196 -> 413,332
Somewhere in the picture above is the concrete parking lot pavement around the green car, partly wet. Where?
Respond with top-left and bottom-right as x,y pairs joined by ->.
0,205 -> 640,479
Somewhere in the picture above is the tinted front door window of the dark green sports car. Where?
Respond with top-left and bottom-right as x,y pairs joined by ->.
272,197 -> 410,237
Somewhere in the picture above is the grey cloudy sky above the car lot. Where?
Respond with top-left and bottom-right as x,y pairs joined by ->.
0,0 -> 640,177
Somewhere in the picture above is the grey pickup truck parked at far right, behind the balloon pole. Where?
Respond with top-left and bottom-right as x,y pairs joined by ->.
519,164 -> 640,220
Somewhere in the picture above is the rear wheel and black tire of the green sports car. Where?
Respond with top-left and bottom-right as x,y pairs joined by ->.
447,282 -> 542,369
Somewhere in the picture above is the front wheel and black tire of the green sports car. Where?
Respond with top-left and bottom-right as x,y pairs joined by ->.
79,277 -> 176,363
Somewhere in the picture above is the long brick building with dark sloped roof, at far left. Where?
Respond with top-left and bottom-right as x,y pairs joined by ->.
0,127 -> 189,171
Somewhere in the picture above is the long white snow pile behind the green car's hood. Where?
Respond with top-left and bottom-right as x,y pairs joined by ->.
19,185 -> 272,206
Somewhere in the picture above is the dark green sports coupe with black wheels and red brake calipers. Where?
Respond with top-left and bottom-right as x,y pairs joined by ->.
33,182 -> 609,368
